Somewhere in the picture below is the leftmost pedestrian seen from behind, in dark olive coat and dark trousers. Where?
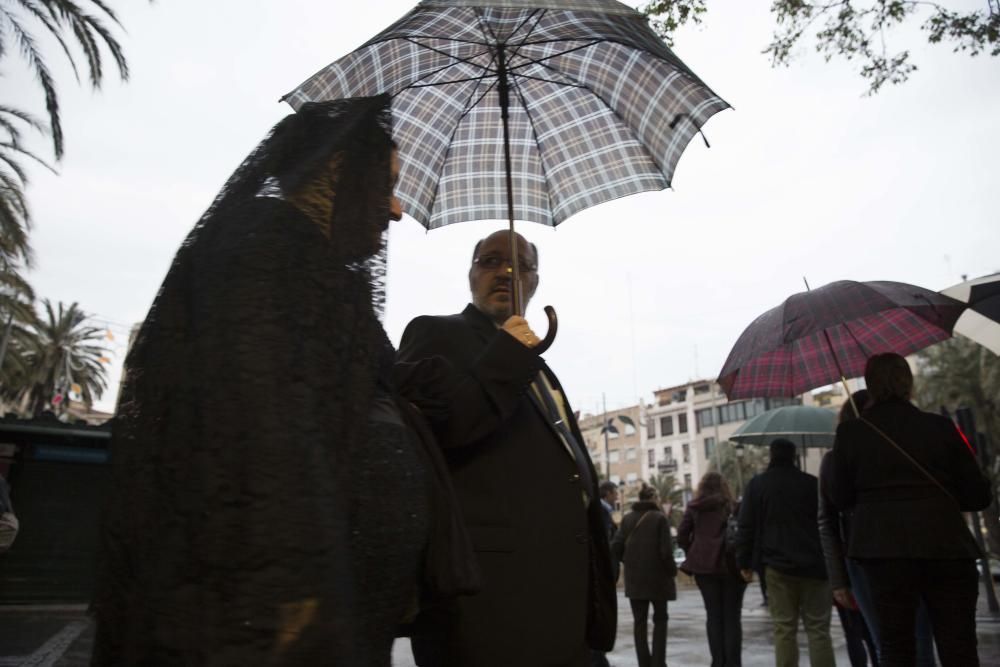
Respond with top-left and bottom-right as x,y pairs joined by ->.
611,486 -> 677,667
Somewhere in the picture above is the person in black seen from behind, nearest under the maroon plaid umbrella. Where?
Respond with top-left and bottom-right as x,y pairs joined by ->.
828,353 -> 991,667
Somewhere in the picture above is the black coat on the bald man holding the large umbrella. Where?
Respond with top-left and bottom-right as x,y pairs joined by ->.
399,305 -> 615,667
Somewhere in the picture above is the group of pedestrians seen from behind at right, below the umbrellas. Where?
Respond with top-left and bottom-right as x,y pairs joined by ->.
612,354 -> 991,667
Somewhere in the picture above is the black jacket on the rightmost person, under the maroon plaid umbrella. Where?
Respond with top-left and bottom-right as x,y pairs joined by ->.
830,400 -> 991,558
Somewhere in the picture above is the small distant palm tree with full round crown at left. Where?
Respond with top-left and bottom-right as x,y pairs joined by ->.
22,299 -> 108,414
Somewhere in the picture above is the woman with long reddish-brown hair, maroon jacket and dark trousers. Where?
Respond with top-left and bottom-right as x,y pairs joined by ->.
677,472 -> 747,667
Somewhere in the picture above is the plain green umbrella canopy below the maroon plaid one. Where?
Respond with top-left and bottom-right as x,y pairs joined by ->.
729,405 -> 837,447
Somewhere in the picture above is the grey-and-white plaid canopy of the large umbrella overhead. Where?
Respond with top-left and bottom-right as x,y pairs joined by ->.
284,0 -> 728,229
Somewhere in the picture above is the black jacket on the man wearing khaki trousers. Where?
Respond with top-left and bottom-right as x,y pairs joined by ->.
736,461 -> 826,579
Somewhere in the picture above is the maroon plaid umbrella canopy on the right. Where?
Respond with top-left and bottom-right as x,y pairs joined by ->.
719,280 -> 965,400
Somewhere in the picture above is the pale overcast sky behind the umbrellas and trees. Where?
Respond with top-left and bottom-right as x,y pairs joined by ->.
4,0 -> 1000,412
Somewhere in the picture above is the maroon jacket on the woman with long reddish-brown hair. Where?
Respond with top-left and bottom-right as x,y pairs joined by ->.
677,495 -> 736,574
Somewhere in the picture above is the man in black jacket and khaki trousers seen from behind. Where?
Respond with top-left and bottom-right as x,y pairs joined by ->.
736,438 -> 836,667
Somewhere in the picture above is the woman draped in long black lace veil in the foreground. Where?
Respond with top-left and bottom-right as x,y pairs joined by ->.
93,96 -> 474,665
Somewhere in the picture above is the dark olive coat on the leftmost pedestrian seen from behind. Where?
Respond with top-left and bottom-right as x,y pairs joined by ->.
611,502 -> 677,600
